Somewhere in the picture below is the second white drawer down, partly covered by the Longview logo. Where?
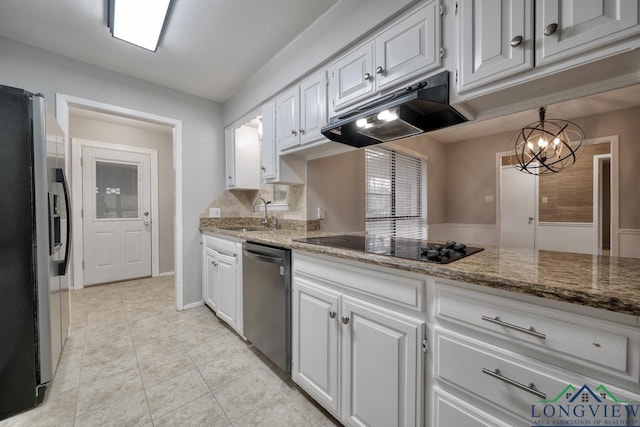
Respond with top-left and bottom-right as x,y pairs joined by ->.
434,329 -> 638,425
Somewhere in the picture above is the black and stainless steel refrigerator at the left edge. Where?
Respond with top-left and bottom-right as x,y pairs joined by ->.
0,86 -> 71,420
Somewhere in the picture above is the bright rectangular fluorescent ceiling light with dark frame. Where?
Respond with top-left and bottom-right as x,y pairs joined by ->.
108,0 -> 174,52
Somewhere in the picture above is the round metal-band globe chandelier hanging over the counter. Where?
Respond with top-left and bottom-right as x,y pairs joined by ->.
510,107 -> 584,175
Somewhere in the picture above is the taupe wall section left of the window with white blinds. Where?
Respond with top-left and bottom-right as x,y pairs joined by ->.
307,149 -> 366,231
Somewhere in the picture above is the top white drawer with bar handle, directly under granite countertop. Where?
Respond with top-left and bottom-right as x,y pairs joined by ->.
434,286 -> 638,381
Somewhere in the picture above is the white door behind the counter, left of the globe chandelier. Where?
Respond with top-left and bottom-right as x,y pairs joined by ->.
500,166 -> 538,249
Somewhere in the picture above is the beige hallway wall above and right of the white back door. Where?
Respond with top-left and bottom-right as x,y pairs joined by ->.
69,115 -> 174,273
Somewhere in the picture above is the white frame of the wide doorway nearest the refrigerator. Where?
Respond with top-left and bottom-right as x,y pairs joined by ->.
56,93 -> 185,310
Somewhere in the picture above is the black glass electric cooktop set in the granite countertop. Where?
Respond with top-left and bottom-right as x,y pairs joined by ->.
295,235 -> 484,264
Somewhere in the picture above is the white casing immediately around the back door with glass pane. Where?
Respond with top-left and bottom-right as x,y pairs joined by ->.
71,138 -> 160,289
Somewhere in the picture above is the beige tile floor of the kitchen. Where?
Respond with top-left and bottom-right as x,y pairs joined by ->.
0,277 -> 339,427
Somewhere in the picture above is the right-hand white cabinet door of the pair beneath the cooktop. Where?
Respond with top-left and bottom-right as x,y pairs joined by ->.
341,296 -> 425,427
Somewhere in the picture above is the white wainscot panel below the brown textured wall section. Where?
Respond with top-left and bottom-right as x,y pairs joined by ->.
536,222 -> 595,254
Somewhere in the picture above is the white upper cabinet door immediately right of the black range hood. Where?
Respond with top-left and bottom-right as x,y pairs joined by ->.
457,0 -> 533,92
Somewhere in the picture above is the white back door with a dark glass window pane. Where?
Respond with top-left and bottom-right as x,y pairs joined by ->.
82,147 -> 151,285
